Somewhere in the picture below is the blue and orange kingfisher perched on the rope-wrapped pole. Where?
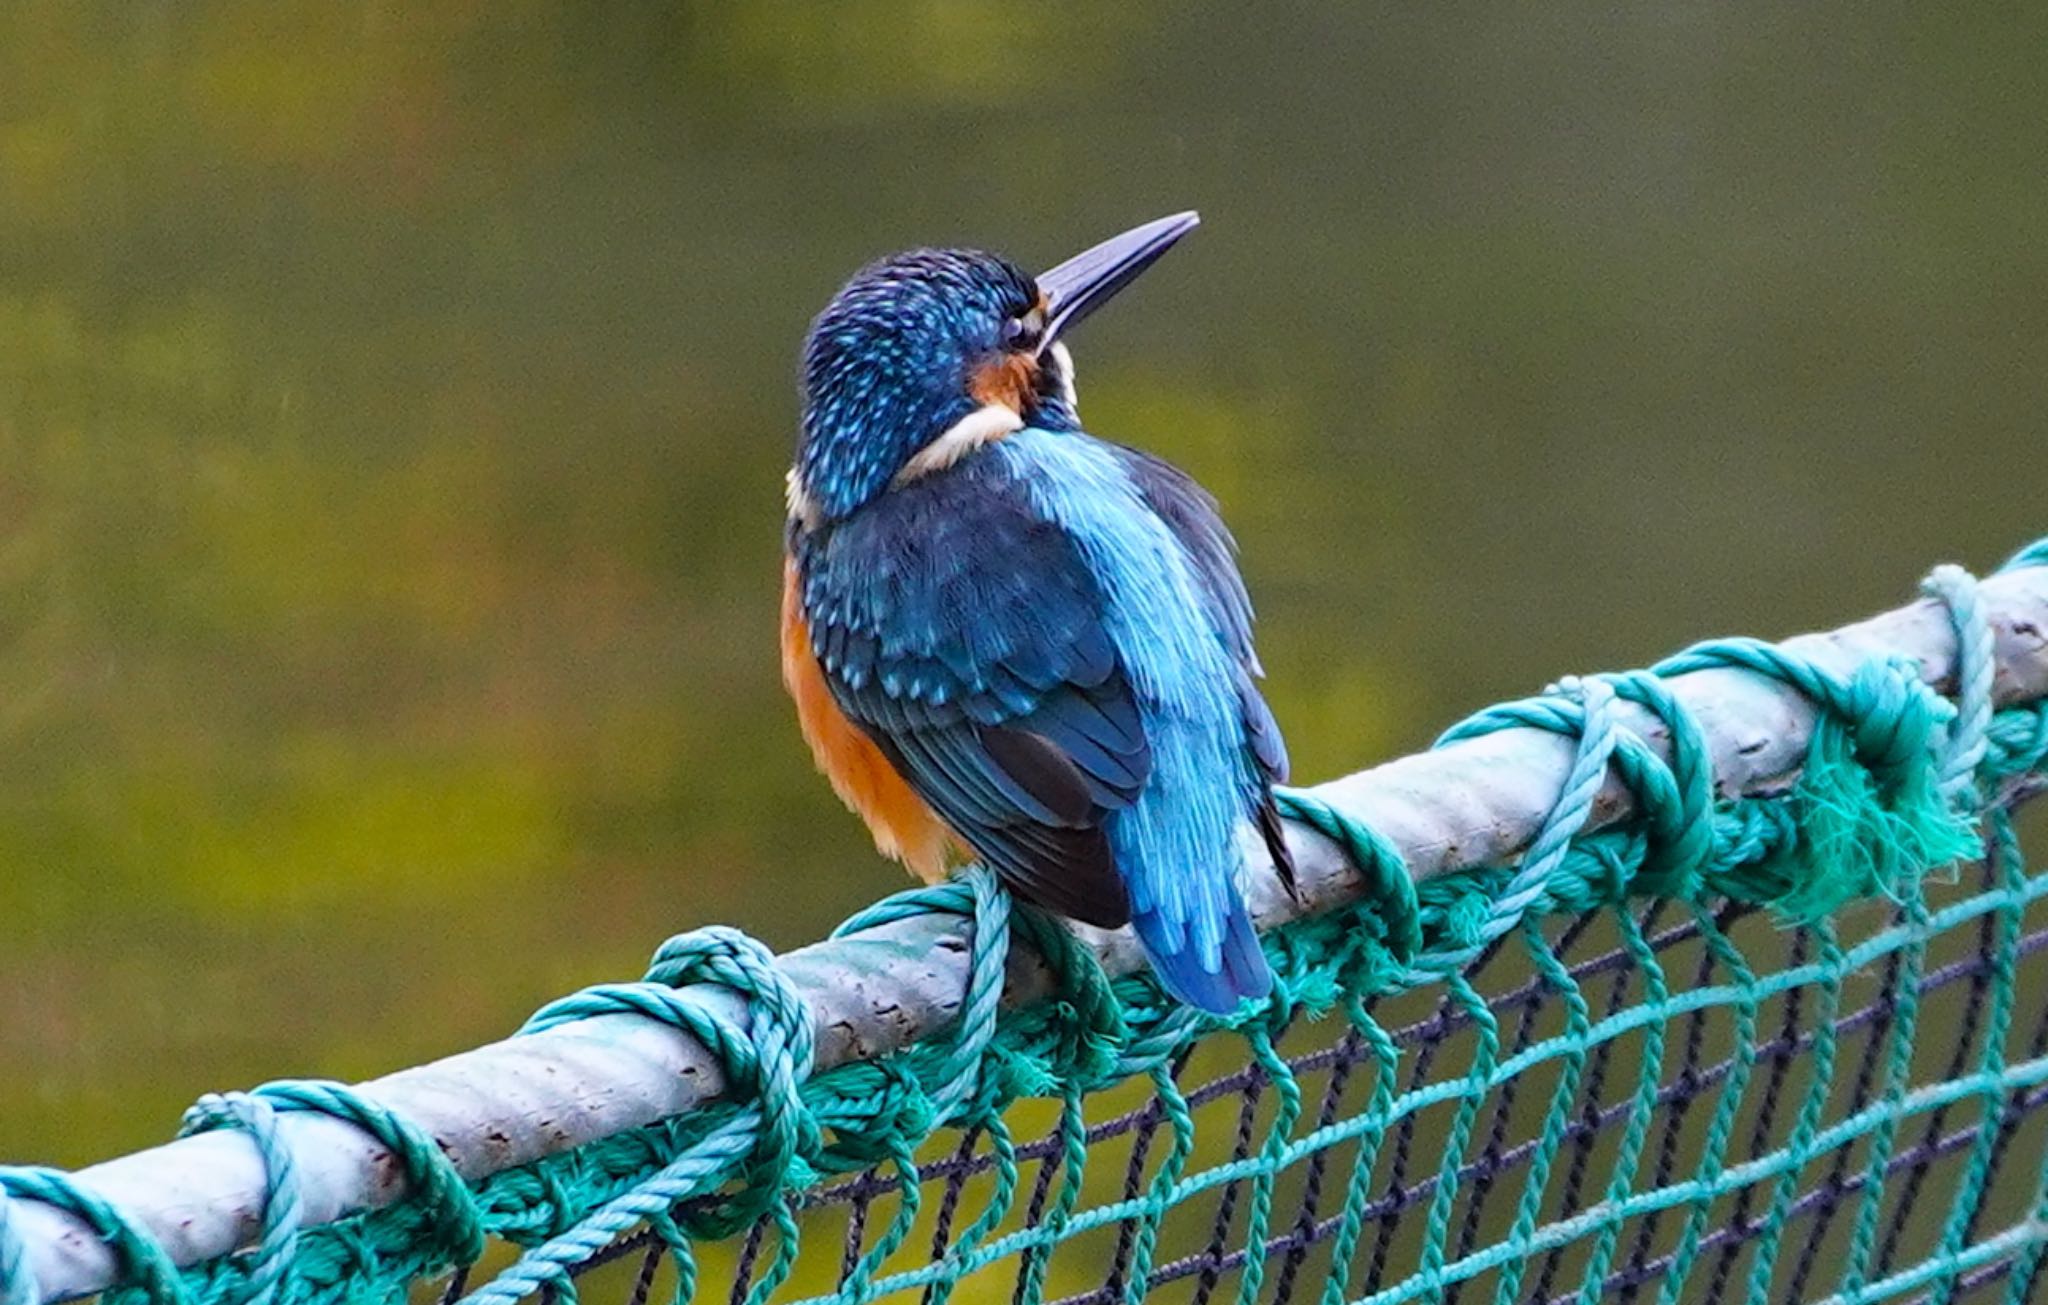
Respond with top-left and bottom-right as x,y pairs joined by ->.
780,213 -> 1294,1014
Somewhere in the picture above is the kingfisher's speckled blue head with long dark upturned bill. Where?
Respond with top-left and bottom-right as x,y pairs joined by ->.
788,213 -> 1196,524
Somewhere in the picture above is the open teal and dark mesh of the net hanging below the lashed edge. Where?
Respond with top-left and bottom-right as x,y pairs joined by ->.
475,811 -> 2048,1305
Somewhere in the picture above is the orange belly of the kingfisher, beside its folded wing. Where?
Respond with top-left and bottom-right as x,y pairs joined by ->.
782,561 -> 961,883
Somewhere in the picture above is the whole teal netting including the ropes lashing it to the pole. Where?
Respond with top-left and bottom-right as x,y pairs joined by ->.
0,545 -> 2048,1305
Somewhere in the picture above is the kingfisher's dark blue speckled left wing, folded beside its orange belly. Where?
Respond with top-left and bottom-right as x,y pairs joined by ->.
791,459 -> 1151,928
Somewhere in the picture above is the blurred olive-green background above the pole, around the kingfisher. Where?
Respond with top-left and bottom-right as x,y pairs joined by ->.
0,0 -> 2048,1164
